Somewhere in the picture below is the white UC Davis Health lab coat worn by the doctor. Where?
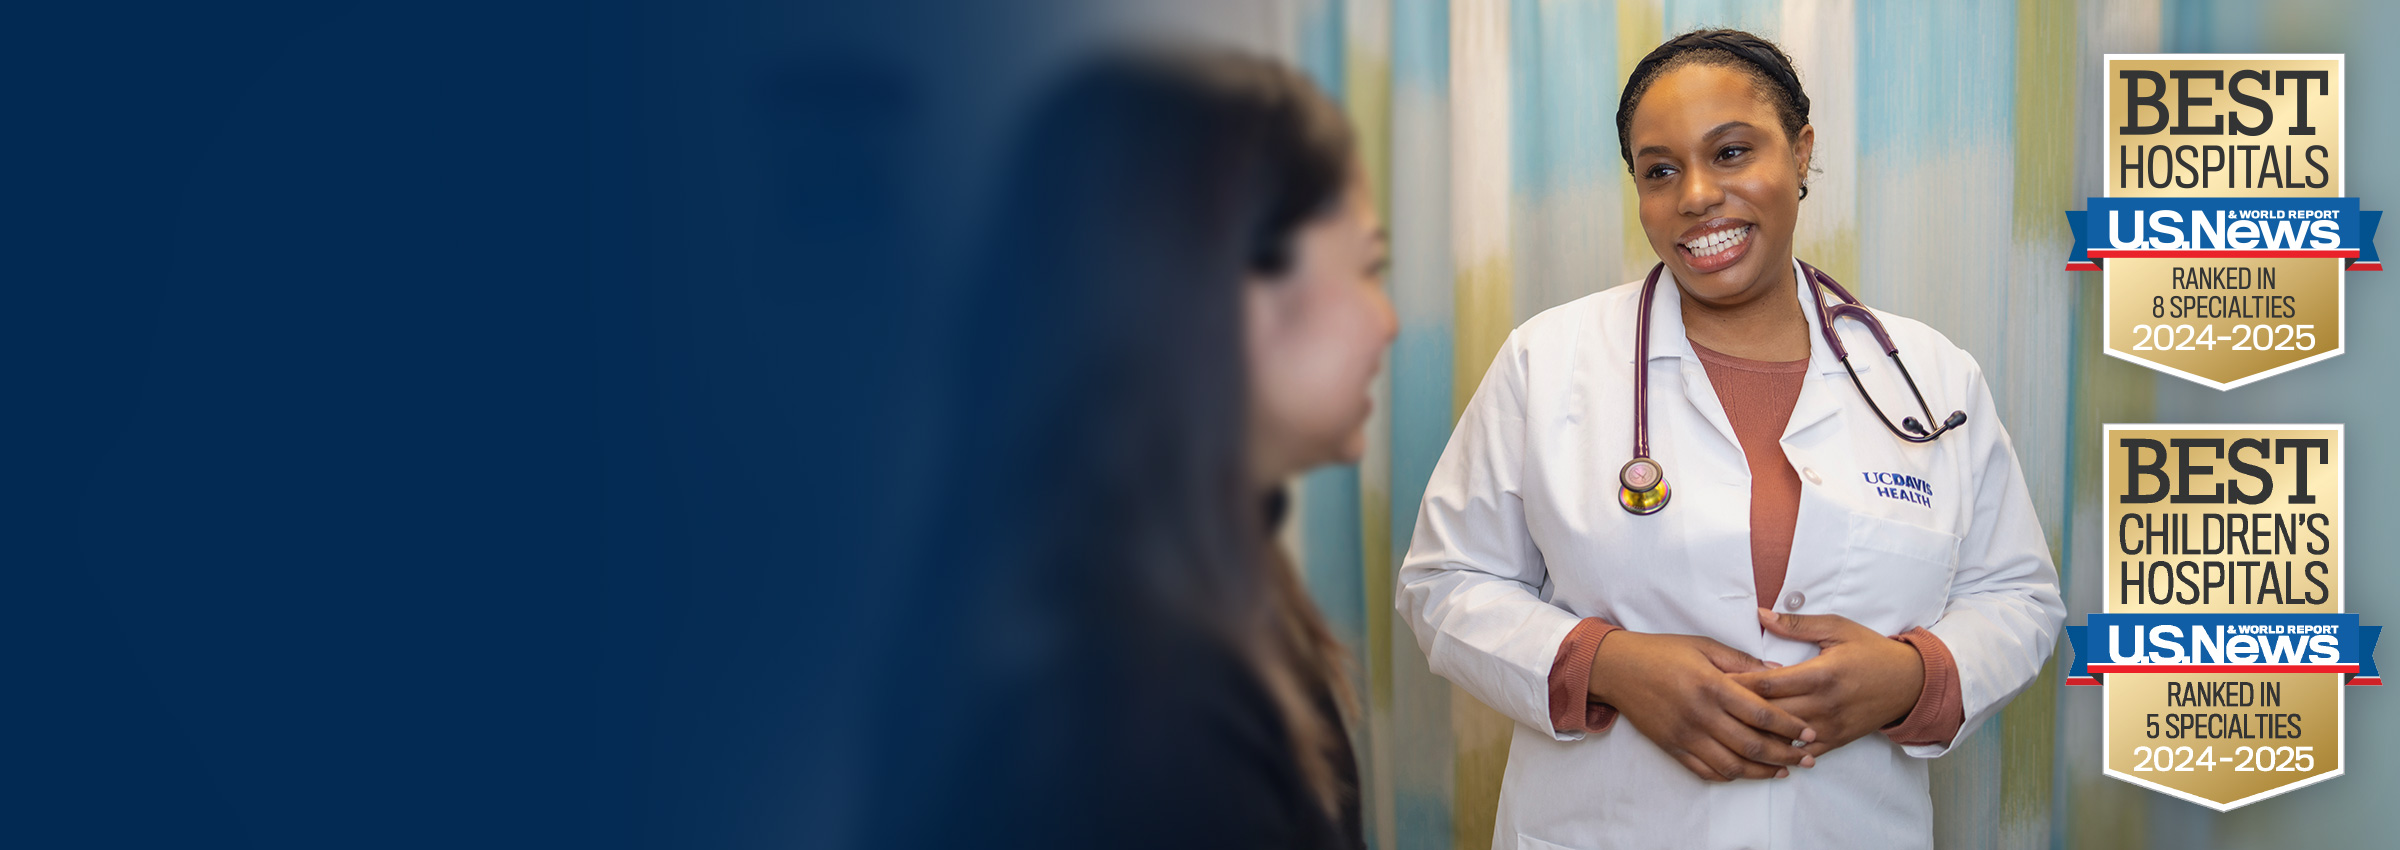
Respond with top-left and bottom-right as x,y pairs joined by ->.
1397,267 -> 2066,850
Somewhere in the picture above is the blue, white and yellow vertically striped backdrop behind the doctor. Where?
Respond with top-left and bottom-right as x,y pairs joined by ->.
1118,0 -> 2390,850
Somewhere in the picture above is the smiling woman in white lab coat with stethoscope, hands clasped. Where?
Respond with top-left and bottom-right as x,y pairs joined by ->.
1397,31 -> 2064,850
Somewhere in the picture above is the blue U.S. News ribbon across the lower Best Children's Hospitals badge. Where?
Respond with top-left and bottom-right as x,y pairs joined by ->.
2066,615 -> 2383,684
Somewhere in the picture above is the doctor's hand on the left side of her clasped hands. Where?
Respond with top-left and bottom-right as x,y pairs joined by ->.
1591,631 -> 1817,783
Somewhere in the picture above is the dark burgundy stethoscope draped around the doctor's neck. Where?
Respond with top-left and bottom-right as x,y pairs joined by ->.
1618,262 -> 1966,516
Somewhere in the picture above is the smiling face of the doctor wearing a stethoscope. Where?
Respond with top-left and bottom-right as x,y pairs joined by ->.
1627,65 -> 1817,305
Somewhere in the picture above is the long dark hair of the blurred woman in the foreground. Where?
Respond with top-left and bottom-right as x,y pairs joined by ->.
921,50 -> 1356,812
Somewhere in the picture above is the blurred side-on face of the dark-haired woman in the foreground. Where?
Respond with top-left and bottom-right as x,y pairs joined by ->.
1243,178 -> 1399,485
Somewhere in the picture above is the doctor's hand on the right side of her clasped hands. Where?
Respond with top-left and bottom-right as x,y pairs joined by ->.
1733,607 -> 1925,756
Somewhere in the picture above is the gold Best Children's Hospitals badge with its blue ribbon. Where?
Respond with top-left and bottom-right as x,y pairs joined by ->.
2066,425 -> 2383,812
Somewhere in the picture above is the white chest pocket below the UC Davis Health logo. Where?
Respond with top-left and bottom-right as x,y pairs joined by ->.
1834,514 -> 1958,634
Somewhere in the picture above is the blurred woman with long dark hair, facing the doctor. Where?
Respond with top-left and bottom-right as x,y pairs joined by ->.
862,53 -> 1397,848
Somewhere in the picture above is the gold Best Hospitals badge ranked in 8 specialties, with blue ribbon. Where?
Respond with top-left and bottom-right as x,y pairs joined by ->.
2066,53 -> 2383,389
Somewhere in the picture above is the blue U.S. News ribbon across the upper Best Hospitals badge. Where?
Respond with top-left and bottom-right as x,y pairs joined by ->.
2066,197 -> 2383,271
